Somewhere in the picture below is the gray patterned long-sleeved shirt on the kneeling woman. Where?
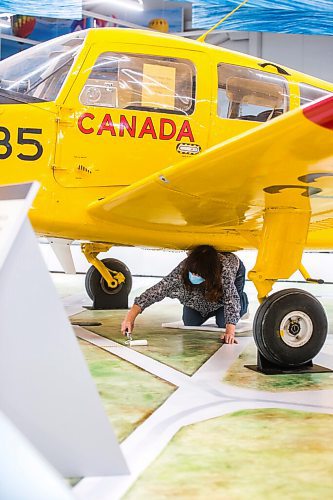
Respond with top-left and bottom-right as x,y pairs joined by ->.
134,252 -> 240,325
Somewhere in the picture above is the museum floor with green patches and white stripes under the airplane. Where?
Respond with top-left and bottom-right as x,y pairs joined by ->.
52,274 -> 333,500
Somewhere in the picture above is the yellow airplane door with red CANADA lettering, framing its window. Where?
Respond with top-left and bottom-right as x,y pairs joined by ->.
56,41 -> 212,188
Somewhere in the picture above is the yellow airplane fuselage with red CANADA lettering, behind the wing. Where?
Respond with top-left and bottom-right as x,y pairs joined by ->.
0,29 -> 333,250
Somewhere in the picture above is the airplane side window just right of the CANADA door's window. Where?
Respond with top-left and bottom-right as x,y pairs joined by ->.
217,63 -> 289,122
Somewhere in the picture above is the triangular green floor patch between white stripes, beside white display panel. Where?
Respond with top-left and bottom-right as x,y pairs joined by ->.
79,340 -> 175,441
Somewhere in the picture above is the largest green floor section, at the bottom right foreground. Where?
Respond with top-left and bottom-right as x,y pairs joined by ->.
123,409 -> 333,500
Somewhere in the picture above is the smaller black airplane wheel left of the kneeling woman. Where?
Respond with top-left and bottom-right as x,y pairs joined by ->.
85,259 -> 132,300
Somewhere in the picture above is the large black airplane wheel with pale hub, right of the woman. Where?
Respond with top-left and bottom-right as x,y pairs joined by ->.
253,288 -> 327,368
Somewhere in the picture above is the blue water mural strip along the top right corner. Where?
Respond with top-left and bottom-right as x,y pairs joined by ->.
172,0 -> 333,35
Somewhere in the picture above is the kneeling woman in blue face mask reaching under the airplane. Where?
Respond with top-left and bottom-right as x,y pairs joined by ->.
121,245 -> 248,344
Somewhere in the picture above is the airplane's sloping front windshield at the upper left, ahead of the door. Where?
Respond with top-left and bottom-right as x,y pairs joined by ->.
0,31 -> 86,101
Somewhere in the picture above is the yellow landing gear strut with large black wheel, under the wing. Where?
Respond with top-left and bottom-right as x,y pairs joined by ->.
248,201 -> 327,373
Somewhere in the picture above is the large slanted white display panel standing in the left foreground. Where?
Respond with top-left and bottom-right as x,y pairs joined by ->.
0,184 -> 128,477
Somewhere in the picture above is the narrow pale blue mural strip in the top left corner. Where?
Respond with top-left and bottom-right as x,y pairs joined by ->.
0,0 -> 82,19
